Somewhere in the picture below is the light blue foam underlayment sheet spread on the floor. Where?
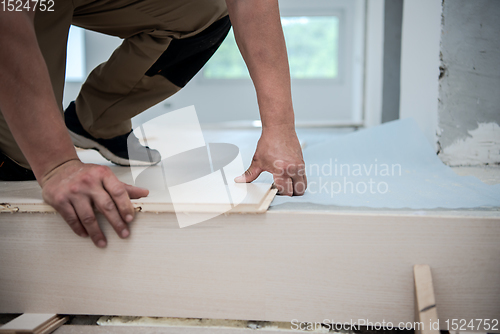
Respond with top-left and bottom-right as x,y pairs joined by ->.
272,118 -> 500,209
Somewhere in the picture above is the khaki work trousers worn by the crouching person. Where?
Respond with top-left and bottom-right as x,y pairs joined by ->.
0,0 -> 230,168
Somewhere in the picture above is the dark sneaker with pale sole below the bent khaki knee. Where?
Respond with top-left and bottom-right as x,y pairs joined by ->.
64,102 -> 161,166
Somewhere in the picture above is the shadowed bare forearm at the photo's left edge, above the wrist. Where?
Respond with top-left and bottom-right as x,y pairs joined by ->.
0,12 -> 78,182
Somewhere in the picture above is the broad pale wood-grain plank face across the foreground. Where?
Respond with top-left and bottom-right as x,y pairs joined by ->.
0,210 -> 500,332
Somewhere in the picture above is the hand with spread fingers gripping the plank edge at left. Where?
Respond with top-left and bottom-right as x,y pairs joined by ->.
40,160 -> 149,248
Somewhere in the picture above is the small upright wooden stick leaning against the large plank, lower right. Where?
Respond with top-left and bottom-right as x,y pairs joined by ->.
413,264 -> 439,334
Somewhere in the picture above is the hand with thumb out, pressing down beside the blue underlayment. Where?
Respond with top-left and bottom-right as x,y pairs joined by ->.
234,124 -> 307,196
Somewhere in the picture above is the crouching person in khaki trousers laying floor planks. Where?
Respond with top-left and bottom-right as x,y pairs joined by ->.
0,0 -> 307,247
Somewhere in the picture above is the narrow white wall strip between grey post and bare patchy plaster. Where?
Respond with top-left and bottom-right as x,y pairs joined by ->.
400,0 -> 442,149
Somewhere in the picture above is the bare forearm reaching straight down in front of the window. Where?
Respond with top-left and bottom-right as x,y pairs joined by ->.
226,0 -> 294,127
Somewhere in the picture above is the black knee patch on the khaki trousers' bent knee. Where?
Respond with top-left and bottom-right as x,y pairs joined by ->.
146,16 -> 231,87
